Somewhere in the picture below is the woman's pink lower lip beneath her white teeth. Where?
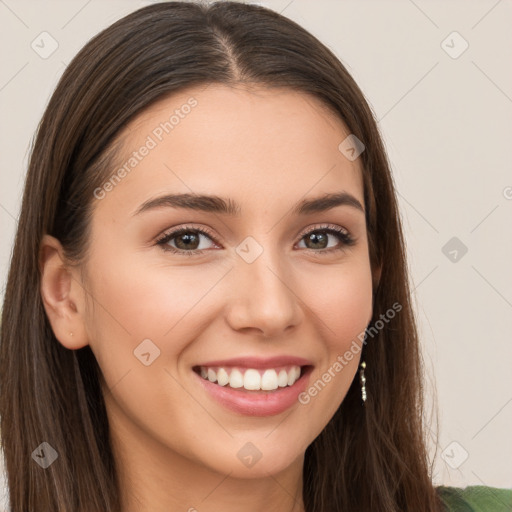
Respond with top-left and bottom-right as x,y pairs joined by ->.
193,366 -> 312,416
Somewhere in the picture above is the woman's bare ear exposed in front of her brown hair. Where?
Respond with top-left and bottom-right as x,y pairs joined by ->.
39,235 -> 88,350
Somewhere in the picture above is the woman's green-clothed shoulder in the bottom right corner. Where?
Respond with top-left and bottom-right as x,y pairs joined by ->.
436,485 -> 512,512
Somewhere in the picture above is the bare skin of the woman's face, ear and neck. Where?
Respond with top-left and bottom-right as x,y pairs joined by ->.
41,84 -> 372,512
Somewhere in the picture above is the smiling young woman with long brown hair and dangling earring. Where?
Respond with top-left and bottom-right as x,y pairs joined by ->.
0,2 -> 510,512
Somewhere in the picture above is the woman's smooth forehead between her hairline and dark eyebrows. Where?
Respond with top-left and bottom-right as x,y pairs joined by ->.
93,84 -> 364,218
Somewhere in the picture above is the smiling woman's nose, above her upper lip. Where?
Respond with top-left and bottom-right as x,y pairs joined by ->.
226,246 -> 302,338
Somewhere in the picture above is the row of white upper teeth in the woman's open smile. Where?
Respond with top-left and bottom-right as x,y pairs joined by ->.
195,366 -> 300,391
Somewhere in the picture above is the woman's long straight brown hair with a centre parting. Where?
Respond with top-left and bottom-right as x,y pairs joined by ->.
0,2 -> 440,512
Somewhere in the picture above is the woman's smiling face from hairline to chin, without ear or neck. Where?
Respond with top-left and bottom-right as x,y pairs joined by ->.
80,85 -> 372,478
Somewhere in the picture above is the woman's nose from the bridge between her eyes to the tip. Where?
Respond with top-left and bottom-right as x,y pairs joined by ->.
228,236 -> 300,336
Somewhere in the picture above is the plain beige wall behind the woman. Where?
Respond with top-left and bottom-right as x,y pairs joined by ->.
0,0 -> 512,506
